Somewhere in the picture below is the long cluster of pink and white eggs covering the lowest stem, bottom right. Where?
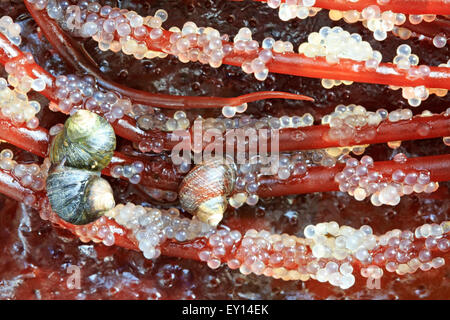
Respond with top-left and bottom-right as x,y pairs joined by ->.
199,221 -> 450,289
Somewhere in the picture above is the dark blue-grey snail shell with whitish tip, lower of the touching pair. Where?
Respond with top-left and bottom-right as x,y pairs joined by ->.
47,166 -> 115,225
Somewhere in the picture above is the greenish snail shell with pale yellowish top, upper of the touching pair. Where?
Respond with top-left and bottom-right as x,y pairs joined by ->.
50,110 -> 116,171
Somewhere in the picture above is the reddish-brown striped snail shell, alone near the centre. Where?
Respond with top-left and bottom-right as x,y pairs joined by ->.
179,158 -> 236,226
